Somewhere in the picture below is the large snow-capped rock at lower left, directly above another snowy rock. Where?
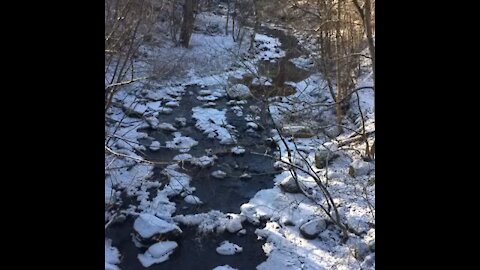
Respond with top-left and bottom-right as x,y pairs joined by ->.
133,213 -> 182,239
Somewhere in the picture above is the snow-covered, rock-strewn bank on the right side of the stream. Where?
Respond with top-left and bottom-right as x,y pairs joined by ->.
248,23 -> 375,270
